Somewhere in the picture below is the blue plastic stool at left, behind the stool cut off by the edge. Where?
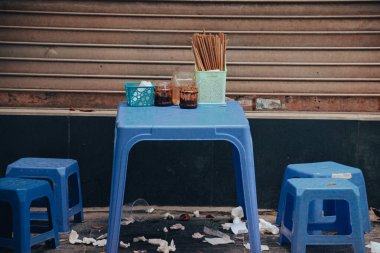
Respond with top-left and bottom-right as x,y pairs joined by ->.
6,158 -> 84,233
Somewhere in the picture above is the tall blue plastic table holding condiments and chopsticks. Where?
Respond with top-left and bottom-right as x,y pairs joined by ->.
107,102 -> 260,253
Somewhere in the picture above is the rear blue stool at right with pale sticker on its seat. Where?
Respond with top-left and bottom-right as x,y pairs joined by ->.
276,162 -> 371,232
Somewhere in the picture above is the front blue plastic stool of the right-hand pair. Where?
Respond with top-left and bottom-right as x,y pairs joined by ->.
280,178 -> 365,253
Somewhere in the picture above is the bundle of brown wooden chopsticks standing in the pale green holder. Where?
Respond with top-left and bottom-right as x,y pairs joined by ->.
192,32 -> 227,71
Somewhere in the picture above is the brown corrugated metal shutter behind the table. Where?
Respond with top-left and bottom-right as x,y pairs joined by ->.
0,0 -> 380,111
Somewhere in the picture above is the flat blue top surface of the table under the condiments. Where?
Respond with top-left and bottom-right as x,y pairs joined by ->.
116,101 -> 249,128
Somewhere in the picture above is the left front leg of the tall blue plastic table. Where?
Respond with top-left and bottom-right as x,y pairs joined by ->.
106,133 -> 133,253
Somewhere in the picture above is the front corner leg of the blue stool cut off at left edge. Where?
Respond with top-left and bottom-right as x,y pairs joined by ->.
13,202 -> 31,253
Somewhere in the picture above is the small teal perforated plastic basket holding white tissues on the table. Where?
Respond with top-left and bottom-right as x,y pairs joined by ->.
125,82 -> 154,106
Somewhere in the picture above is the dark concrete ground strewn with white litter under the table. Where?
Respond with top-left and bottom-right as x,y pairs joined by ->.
25,207 -> 380,253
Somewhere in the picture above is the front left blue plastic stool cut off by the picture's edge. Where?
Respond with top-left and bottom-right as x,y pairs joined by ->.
0,177 -> 59,253
